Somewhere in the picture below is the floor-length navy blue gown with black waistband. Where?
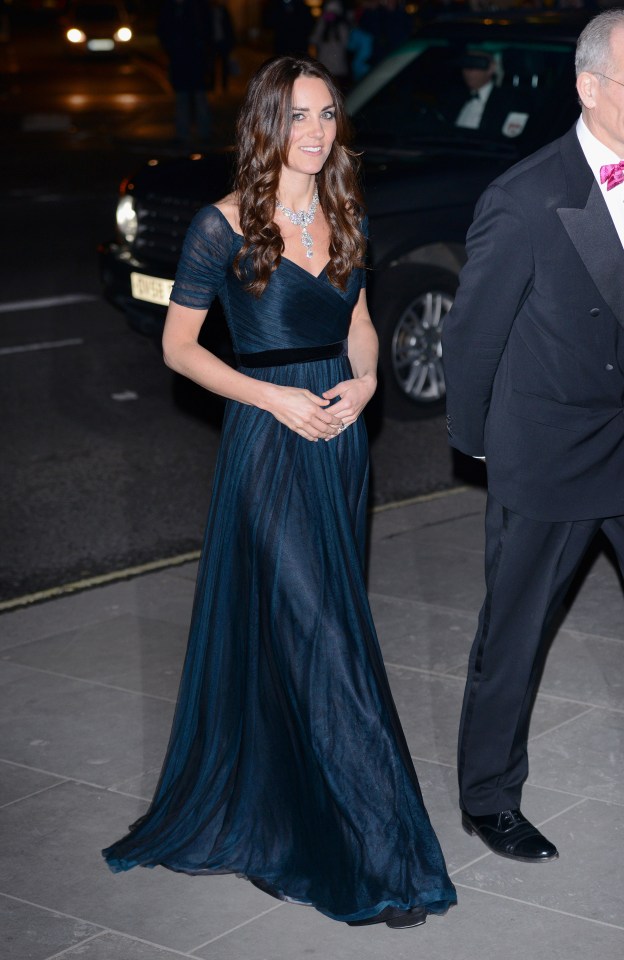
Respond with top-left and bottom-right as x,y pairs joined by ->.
104,207 -> 456,920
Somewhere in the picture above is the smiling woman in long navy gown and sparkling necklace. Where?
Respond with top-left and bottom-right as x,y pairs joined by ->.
104,57 -> 455,926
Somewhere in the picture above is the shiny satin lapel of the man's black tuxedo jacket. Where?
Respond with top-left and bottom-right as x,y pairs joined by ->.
557,141 -> 624,326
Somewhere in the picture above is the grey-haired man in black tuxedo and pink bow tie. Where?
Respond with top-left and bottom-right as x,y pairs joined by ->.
443,9 -> 624,863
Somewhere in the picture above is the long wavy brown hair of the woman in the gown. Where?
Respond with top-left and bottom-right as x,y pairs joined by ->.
234,56 -> 366,297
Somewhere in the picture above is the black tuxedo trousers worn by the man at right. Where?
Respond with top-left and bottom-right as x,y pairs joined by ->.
458,495 -> 624,816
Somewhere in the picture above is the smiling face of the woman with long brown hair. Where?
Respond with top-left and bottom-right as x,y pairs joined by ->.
286,77 -> 336,176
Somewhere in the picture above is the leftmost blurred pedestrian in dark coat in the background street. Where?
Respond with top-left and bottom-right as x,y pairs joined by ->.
157,0 -> 212,146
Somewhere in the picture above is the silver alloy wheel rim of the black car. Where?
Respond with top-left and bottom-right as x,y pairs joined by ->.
392,290 -> 453,403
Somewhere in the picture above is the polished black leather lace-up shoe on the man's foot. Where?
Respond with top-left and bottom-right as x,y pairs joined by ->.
462,810 -> 559,863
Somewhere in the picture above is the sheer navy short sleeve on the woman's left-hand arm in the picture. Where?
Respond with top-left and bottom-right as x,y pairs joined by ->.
171,206 -> 234,310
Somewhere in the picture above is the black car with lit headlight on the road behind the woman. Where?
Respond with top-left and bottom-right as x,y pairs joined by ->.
100,13 -> 587,419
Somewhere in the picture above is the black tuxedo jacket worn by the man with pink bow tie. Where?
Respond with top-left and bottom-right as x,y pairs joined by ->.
442,128 -> 624,520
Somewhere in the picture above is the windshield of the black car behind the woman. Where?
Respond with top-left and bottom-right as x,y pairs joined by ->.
347,40 -> 578,154
